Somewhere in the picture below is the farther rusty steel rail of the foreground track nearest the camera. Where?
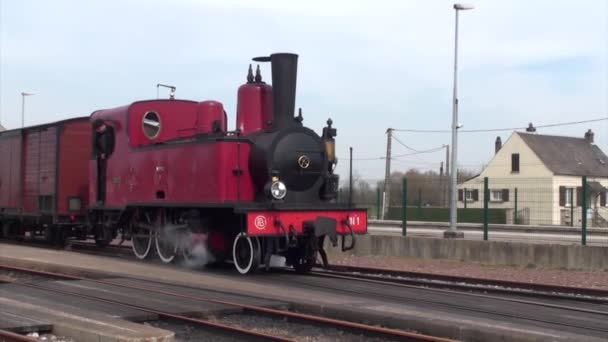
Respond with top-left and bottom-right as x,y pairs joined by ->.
0,264 -> 455,342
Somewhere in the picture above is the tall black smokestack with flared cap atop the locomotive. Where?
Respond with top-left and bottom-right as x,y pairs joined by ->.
253,53 -> 298,130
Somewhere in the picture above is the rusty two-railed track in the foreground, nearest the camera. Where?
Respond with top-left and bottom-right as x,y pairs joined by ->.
0,264 -> 454,342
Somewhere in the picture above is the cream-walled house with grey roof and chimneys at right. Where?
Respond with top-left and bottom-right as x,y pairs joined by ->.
458,125 -> 608,227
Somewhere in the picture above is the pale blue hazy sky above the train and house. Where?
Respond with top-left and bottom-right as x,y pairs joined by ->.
0,0 -> 608,180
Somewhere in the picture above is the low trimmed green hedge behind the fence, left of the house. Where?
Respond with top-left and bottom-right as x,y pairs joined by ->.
387,207 -> 507,224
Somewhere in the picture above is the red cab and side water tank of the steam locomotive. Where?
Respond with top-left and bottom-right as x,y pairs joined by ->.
89,100 -> 253,209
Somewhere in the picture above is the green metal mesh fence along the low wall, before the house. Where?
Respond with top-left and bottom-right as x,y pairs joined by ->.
344,176 -> 608,243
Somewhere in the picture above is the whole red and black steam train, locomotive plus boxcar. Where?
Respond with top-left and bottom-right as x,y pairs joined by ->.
0,53 -> 367,274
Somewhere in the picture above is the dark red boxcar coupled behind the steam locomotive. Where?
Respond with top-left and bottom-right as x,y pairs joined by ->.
0,117 -> 91,239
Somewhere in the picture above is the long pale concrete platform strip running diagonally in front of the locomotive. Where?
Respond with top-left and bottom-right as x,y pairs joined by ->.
0,244 -> 608,342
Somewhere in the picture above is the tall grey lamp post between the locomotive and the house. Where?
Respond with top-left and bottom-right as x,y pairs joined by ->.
443,4 -> 473,238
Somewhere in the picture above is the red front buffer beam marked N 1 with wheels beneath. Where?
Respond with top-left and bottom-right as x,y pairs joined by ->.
233,209 -> 367,274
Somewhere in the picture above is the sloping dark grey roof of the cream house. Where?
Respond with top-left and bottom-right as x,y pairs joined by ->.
517,132 -> 608,177
